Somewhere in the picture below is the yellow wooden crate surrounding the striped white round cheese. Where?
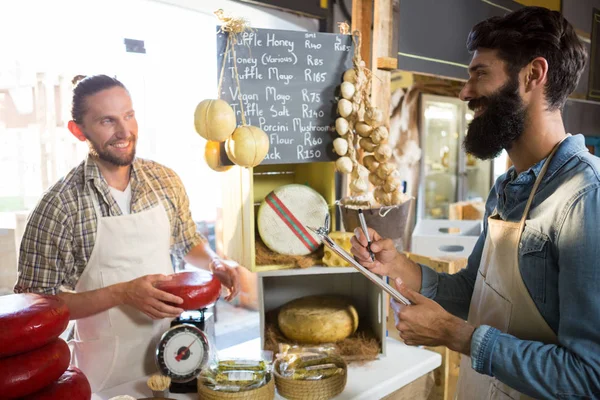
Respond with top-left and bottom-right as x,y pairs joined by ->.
222,162 -> 336,272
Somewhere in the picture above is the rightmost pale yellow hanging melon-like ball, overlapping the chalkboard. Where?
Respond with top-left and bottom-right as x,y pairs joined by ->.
225,125 -> 269,168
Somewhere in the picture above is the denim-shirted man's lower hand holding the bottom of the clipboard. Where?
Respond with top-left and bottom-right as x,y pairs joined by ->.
392,279 -> 475,355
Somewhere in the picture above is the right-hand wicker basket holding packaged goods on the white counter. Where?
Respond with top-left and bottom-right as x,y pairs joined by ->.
273,360 -> 348,400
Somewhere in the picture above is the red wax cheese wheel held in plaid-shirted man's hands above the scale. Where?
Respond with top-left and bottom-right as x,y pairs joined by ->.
156,271 -> 221,310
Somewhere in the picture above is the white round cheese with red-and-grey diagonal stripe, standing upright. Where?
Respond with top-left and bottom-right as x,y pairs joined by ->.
257,184 -> 328,256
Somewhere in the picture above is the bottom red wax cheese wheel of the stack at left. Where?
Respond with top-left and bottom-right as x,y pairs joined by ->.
22,365 -> 92,400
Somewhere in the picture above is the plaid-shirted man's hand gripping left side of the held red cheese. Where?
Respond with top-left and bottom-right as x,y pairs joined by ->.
121,274 -> 183,319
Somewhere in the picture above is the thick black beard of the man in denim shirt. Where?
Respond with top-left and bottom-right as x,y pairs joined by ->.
463,75 -> 527,160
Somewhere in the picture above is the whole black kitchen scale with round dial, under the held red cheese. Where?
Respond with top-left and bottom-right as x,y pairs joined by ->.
155,309 -> 212,393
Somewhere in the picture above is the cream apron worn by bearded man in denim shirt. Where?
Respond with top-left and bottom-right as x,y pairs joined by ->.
456,141 -> 562,400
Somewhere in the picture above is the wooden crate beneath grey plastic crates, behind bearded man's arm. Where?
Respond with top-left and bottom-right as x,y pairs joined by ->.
387,253 -> 467,400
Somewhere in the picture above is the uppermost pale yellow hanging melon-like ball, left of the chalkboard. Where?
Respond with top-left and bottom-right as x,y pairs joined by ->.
194,100 -> 236,142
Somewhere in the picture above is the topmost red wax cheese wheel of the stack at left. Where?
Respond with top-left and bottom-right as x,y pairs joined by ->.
0,293 -> 69,357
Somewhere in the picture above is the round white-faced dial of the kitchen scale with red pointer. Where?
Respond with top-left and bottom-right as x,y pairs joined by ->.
156,324 -> 209,383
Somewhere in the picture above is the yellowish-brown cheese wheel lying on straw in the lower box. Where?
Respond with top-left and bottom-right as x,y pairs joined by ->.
277,296 -> 358,344
